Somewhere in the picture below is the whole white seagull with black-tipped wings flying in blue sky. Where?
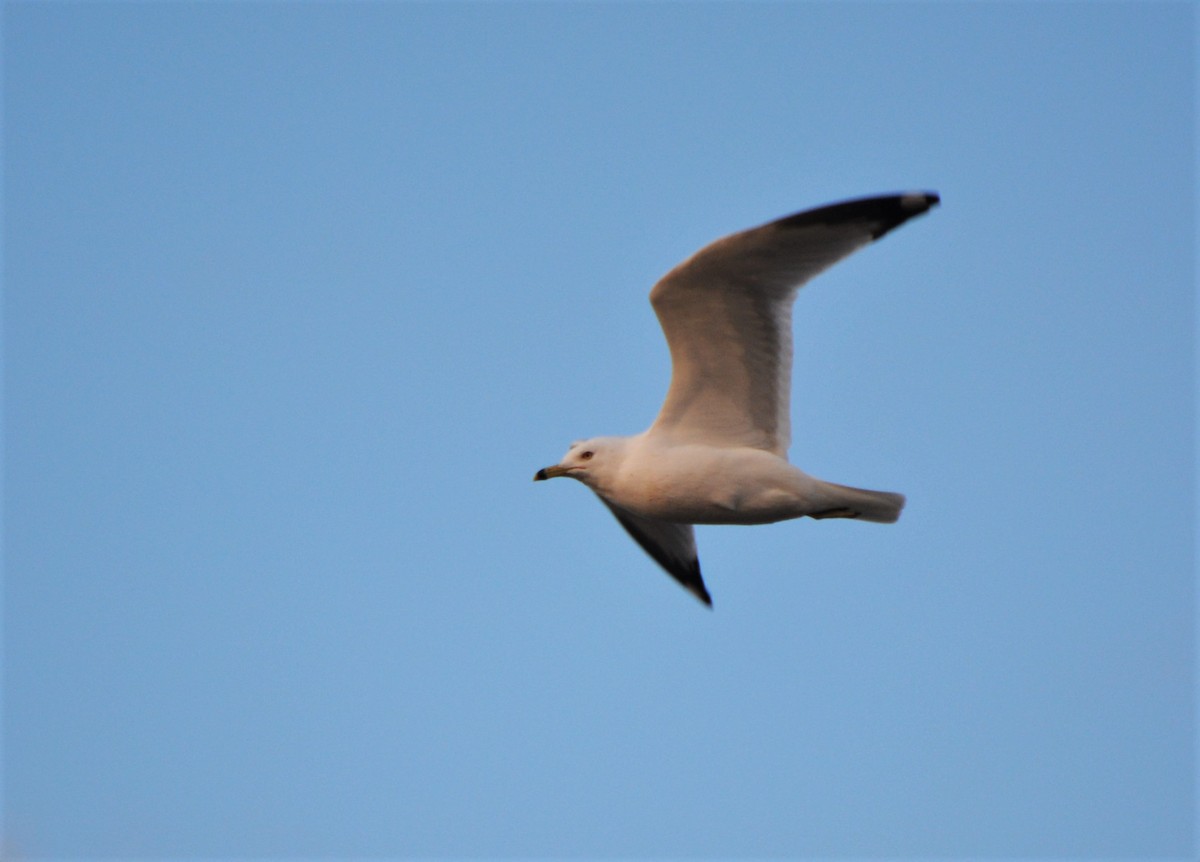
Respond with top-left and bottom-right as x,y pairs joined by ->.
534,192 -> 940,607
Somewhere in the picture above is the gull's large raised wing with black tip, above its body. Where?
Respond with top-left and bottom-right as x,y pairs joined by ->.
635,192 -> 938,456
